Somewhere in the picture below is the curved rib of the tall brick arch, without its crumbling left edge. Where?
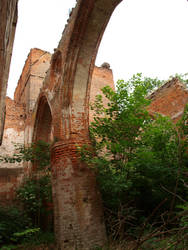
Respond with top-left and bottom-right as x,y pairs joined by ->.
62,0 -> 121,142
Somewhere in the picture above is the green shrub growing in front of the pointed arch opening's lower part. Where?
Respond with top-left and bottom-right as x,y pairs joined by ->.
13,141 -> 53,230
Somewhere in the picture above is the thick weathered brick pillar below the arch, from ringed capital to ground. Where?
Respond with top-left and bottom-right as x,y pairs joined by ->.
52,141 -> 106,250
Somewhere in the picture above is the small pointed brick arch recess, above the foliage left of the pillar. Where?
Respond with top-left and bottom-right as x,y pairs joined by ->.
33,95 -> 53,143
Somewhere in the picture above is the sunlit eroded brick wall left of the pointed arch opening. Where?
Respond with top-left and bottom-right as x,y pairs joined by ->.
0,49 -> 51,203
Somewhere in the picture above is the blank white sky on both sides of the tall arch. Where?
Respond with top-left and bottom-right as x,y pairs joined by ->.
7,0 -> 188,98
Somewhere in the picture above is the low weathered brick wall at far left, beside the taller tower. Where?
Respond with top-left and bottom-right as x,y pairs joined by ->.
0,97 -> 25,205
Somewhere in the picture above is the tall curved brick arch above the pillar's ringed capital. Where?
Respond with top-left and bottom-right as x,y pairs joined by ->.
45,0 -> 122,143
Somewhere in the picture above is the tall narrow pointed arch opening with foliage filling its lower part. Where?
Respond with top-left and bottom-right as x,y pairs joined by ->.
32,96 -> 54,231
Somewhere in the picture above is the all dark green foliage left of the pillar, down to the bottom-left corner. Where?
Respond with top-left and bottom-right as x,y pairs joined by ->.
0,141 -> 54,249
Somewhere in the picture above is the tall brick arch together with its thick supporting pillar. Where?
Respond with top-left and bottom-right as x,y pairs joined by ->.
38,0 -> 122,250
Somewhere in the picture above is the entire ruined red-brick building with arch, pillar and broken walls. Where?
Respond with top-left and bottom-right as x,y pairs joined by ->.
0,0 -> 188,250
